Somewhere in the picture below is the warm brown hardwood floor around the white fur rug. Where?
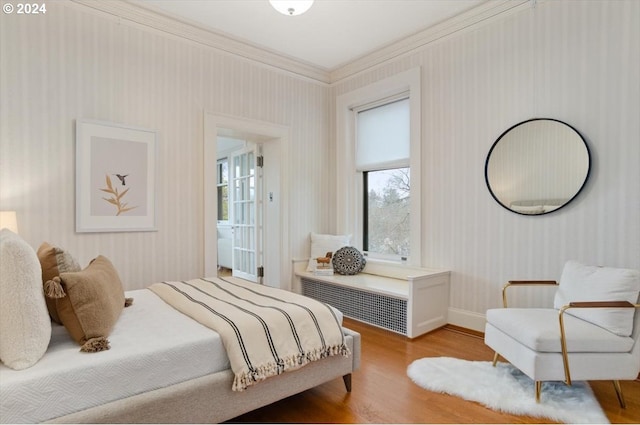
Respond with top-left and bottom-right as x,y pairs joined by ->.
234,319 -> 640,423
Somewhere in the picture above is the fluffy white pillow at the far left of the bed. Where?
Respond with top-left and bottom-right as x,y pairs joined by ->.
0,229 -> 51,370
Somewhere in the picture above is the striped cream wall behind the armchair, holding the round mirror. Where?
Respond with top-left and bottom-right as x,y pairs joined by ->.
332,0 -> 640,327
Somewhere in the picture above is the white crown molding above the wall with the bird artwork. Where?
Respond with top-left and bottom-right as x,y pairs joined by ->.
70,0 -> 330,85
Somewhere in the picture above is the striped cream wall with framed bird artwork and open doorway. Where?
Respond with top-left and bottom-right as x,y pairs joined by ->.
0,0 -> 329,289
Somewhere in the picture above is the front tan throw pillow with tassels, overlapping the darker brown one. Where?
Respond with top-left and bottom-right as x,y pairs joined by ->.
53,255 -> 131,352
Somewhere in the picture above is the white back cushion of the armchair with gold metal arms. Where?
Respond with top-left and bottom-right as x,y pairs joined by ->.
553,261 -> 640,336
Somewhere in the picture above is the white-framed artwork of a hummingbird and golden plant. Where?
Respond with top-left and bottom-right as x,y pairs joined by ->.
76,120 -> 157,232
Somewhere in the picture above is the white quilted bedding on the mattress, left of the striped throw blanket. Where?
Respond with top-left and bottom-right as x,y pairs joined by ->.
0,289 -> 231,423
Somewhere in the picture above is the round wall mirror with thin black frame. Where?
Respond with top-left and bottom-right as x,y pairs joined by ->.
484,118 -> 591,215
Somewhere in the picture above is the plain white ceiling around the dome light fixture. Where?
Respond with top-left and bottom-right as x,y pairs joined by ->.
130,0 -> 487,71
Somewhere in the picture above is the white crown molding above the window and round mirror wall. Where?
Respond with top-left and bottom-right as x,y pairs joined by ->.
330,0 -> 535,85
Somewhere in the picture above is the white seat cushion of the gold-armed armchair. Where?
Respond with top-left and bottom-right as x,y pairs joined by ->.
487,308 -> 634,353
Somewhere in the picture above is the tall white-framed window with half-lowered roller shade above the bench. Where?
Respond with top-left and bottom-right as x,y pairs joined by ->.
335,68 -> 424,267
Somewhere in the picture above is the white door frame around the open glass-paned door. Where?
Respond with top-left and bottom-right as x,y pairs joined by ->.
203,111 -> 291,289
